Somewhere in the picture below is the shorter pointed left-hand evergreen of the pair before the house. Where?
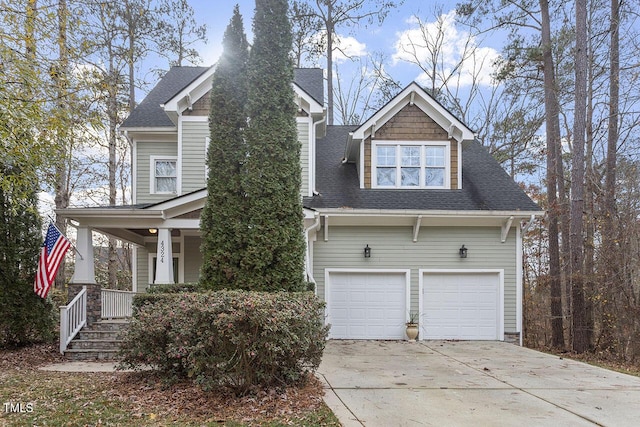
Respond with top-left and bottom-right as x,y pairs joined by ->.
200,5 -> 249,289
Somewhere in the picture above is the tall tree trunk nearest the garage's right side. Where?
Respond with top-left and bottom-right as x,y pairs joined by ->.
540,0 -> 564,349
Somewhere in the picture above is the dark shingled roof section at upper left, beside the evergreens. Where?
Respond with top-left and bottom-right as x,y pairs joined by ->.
120,67 -> 211,128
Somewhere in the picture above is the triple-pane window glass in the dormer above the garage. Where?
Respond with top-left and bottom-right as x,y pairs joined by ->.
373,142 -> 449,188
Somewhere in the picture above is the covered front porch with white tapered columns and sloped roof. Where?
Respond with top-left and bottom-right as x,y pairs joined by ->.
56,190 -> 206,292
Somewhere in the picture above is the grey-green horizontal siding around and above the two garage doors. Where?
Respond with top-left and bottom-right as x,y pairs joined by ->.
313,225 -> 517,332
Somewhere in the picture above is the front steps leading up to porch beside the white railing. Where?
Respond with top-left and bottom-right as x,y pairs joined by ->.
64,319 -> 129,361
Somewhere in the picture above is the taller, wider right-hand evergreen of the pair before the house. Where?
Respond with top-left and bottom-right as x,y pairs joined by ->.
241,0 -> 305,291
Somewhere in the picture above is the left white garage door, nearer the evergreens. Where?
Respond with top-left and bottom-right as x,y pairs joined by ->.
327,272 -> 408,339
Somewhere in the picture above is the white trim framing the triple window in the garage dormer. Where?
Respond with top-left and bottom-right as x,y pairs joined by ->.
371,140 -> 451,190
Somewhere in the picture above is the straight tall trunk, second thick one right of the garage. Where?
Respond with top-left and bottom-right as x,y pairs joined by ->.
569,0 -> 590,353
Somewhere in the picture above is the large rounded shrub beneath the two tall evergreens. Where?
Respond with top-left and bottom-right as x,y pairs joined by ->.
121,291 -> 328,394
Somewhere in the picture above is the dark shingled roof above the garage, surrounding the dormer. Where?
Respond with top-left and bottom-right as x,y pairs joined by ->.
304,126 -> 540,212
